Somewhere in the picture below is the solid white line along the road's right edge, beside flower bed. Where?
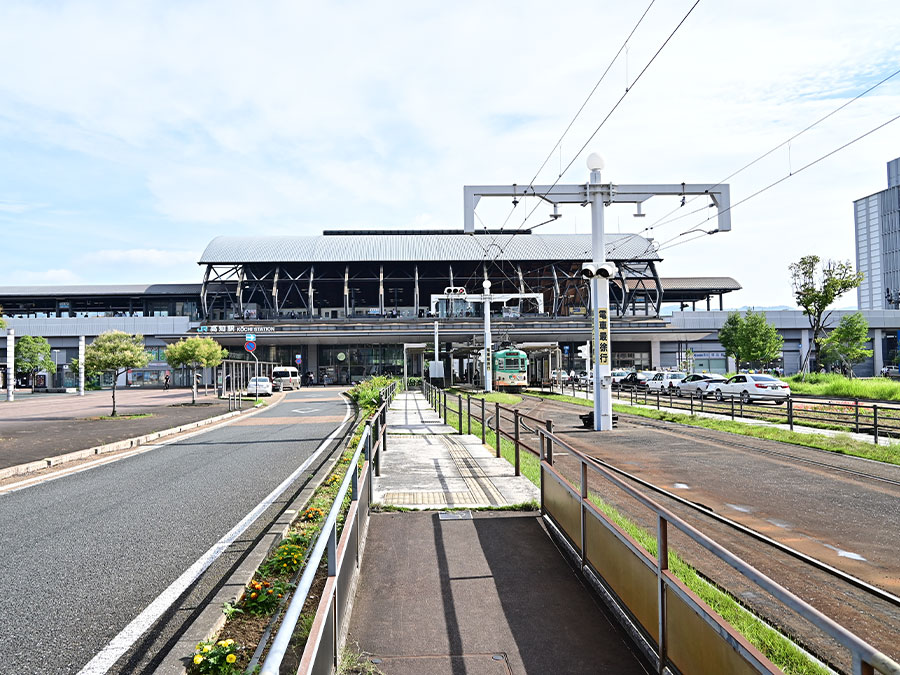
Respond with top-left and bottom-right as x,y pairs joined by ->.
79,400 -> 351,675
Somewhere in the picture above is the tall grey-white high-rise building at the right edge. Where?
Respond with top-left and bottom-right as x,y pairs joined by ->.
853,157 -> 900,309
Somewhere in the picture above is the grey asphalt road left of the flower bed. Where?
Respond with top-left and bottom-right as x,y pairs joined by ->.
0,389 -> 347,675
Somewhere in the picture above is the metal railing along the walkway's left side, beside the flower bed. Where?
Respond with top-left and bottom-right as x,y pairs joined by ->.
260,382 -> 398,675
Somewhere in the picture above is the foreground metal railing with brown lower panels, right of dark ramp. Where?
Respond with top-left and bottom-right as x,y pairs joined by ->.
537,428 -> 900,675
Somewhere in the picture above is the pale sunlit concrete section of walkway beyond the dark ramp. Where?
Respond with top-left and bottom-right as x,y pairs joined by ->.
373,391 -> 540,508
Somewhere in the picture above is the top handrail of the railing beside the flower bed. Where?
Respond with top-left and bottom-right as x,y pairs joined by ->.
260,382 -> 397,675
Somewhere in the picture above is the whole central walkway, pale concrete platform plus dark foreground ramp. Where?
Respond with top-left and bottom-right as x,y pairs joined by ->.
347,392 -> 647,675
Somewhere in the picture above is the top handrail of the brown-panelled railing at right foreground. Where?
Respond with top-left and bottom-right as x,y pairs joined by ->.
537,428 -> 900,675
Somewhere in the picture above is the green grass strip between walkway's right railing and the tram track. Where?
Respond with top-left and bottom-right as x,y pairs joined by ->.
447,394 -> 831,675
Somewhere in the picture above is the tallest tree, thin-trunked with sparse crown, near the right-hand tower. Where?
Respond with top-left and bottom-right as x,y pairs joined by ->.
788,255 -> 863,377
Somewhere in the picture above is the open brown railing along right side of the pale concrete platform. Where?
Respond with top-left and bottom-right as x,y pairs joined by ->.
422,380 -> 553,476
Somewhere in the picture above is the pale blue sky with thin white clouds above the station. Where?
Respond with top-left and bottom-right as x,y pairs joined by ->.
0,0 -> 900,306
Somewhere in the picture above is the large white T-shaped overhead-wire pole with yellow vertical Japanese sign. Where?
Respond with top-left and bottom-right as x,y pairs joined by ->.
463,160 -> 731,431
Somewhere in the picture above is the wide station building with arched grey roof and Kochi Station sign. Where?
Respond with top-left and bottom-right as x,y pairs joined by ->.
0,230 -> 898,387
